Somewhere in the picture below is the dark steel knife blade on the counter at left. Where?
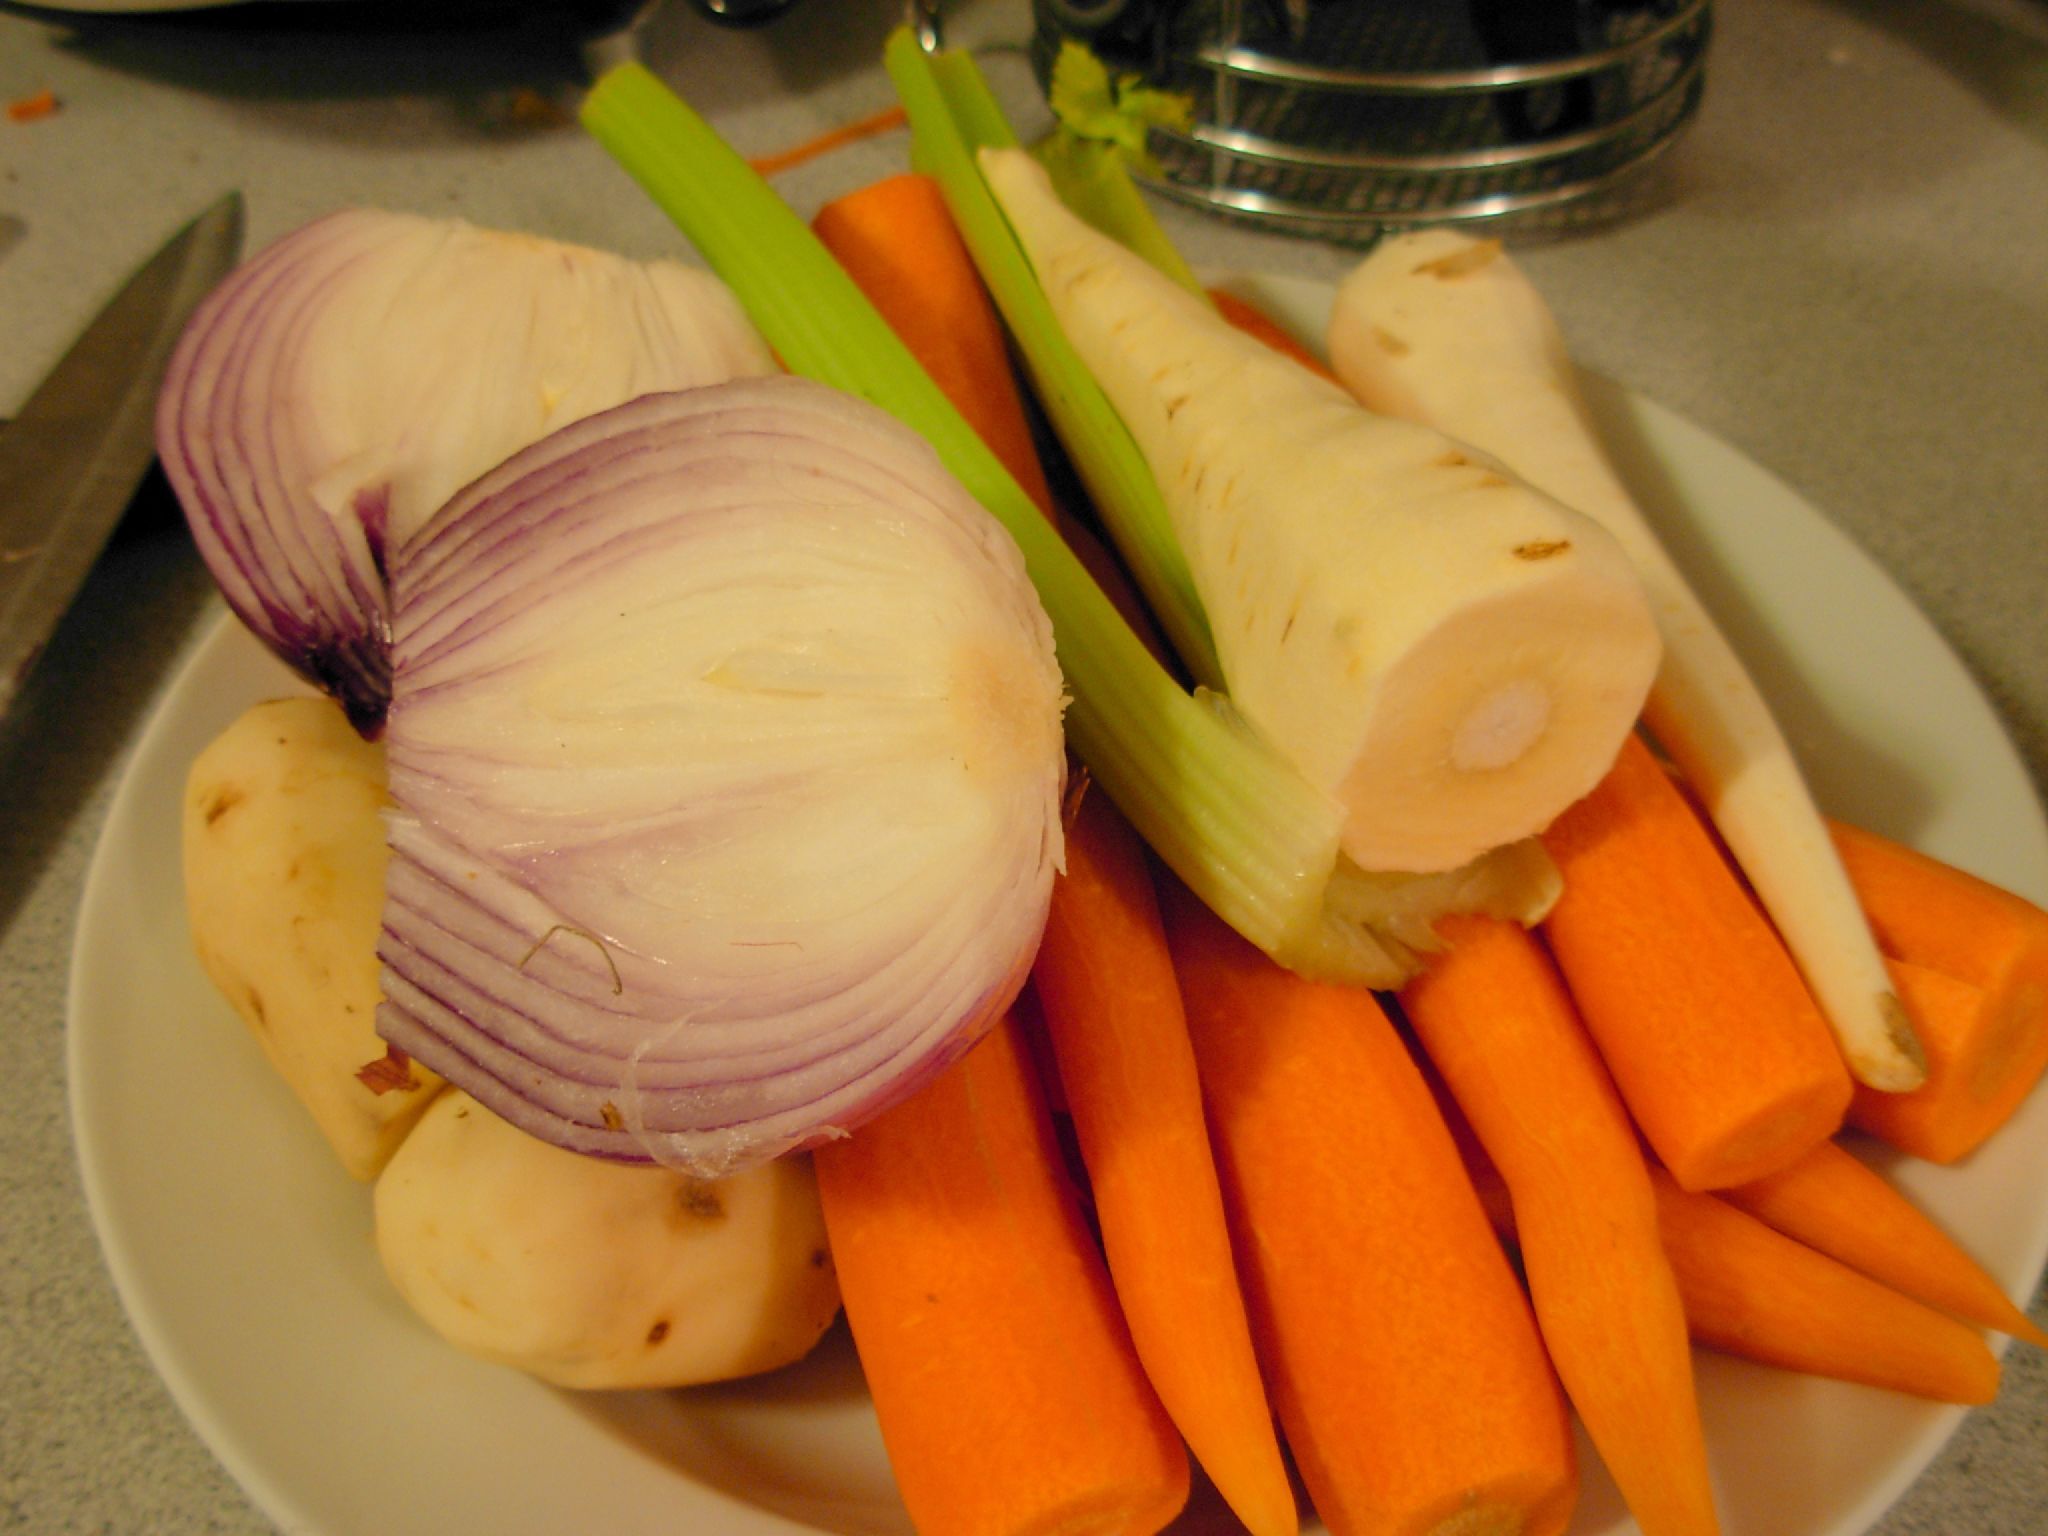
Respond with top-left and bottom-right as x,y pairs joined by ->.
0,193 -> 242,715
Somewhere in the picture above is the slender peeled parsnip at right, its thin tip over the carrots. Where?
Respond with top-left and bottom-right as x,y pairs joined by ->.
1329,229 -> 1925,1092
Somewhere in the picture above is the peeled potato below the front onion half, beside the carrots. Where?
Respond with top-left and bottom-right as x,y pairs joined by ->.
377,1087 -> 840,1389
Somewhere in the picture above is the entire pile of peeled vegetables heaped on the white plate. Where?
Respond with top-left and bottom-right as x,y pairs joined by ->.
162,33 -> 2048,1536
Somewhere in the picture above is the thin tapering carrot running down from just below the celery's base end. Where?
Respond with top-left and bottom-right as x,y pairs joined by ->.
1401,918 -> 1720,1536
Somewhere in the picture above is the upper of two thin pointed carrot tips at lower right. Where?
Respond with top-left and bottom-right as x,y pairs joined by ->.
1722,1141 -> 2048,1348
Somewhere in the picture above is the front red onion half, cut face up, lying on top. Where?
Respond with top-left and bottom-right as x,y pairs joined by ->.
379,377 -> 1063,1176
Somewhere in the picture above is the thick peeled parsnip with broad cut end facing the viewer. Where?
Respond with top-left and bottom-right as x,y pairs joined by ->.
981,150 -> 1659,872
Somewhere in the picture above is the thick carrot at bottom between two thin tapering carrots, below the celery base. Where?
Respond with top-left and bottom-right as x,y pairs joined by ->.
1165,887 -> 1577,1536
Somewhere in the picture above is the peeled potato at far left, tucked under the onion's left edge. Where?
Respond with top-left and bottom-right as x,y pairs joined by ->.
184,698 -> 440,1180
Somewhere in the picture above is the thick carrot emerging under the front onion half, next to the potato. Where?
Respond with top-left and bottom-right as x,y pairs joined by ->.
813,1020 -> 1188,1536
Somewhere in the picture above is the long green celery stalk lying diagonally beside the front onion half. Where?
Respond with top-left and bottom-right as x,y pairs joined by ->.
582,60 -> 1376,981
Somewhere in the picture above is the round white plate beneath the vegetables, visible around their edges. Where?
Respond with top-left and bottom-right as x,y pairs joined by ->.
70,283 -> 2048,1536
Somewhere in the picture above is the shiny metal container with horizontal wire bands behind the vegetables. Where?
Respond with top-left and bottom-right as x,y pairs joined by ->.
1032,0 -> 1712,240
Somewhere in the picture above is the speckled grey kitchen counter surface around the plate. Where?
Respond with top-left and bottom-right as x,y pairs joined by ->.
0,0 -> 2048,1536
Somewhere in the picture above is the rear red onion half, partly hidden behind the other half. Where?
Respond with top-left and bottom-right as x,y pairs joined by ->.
158,209 -> 774,731
